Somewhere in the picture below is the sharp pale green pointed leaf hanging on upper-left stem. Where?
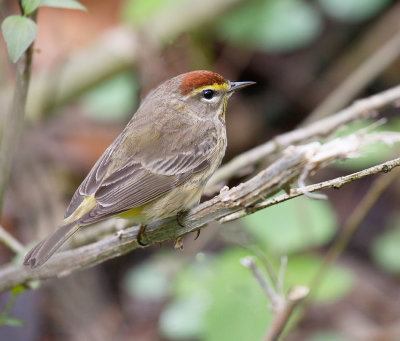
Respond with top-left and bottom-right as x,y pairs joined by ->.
1,15 -> 37,63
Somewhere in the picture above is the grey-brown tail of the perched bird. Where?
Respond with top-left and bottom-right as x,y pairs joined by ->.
24,222 -> 79,268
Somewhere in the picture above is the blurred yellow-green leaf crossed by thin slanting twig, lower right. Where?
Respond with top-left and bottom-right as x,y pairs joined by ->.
285,255 -> 354,303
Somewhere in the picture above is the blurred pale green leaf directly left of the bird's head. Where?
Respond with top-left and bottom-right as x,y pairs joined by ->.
81,72 -> 139,121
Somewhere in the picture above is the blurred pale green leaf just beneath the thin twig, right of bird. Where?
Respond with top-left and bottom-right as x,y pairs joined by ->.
242,197 -> 337,255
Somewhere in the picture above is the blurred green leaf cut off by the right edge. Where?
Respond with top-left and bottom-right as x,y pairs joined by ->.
371,213 -> 400,274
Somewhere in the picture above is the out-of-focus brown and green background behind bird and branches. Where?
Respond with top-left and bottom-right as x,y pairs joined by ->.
0,0 -> 400,341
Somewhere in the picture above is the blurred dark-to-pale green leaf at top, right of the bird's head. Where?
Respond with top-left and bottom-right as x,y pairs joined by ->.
217,0 -> 322,52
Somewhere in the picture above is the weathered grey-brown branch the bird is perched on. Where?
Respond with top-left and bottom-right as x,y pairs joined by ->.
0,127 -> 400,291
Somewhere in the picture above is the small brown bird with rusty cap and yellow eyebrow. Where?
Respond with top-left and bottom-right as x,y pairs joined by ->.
24,70 -> 255,268
